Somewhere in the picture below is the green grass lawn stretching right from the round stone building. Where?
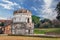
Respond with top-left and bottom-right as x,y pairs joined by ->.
34,28 -> 60,34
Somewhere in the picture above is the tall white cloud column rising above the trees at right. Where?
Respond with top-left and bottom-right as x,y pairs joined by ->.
38,0 -> 57,20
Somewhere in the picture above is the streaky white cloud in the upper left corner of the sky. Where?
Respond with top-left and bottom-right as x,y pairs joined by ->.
0,0 -> 21,9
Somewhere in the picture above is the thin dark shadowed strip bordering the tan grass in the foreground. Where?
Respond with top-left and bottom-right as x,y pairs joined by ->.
8,34 -> 60,38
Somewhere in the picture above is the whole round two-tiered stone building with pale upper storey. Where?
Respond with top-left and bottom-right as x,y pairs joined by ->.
11,9 -> 34,34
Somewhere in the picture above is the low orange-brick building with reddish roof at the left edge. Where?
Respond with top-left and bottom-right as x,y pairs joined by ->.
0,20 -> 12,34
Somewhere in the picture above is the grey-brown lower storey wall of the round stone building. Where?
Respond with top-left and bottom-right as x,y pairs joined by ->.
12,23 -> 34,34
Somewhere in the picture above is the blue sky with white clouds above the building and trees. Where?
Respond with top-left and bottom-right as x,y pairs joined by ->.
0,0 -> 60,20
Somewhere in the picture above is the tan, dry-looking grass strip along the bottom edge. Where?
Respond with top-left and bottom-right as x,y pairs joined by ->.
0,36 -> 60,40
